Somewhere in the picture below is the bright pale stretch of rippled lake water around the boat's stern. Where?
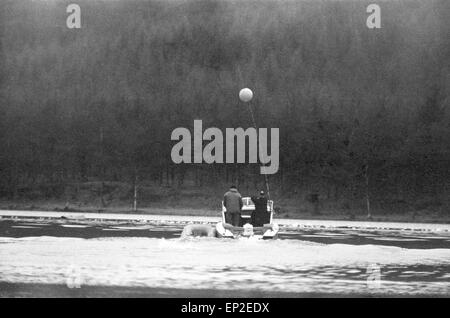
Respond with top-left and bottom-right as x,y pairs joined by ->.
0,222 -> 450,295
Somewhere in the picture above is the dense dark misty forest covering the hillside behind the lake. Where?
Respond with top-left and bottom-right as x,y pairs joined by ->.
0,0 -> 450,214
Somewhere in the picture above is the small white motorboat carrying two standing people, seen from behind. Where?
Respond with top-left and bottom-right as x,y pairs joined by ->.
216,197 -> 279,239
